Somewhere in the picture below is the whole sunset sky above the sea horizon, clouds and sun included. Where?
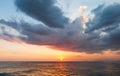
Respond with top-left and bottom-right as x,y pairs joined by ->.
0,0 -> 120,61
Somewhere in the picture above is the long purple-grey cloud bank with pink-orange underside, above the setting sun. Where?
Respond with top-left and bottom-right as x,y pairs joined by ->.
0,17 -> 99,53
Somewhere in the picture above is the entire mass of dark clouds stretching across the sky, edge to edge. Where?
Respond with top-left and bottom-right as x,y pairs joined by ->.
0,0 -> 120,53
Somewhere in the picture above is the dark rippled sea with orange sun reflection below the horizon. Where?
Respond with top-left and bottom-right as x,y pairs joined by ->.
0,62 -> 120,76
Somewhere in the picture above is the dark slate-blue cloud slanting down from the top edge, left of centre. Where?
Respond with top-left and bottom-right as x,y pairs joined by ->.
15,0 -> 68,27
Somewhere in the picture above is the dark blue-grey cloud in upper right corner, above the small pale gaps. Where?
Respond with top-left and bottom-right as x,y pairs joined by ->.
87,3 -> 120,32
